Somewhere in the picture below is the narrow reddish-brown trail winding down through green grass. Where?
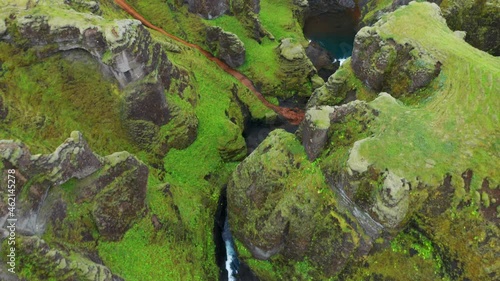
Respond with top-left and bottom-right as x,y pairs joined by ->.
114,0 -> 304,125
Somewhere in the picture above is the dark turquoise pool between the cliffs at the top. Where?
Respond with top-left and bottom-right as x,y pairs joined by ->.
304,11 -> 357,60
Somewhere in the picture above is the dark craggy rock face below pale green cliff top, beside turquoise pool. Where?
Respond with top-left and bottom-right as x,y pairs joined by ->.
351,27 -> 441,97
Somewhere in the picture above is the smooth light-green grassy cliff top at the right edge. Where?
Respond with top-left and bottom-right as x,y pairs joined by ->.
352,3 -> 500,188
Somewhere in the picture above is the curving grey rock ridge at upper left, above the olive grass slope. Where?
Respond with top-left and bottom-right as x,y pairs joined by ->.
0,1 -> 197,150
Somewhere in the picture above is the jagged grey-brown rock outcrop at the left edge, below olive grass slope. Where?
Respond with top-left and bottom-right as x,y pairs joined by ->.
0,131 -> 148,240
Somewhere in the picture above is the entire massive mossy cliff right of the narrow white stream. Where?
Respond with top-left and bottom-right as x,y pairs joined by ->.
228,2 -> 500,280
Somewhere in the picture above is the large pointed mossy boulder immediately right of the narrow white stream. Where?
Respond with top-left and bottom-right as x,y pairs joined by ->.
227,129 -> 370,279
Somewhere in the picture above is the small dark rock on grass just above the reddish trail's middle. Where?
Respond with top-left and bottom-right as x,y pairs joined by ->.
207,26 -> 246,68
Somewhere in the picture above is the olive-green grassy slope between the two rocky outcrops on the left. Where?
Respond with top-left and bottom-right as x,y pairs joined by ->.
0,43 -> 134,155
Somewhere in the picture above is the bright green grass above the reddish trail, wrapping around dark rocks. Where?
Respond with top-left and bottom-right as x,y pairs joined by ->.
130,0 -> 305,95
